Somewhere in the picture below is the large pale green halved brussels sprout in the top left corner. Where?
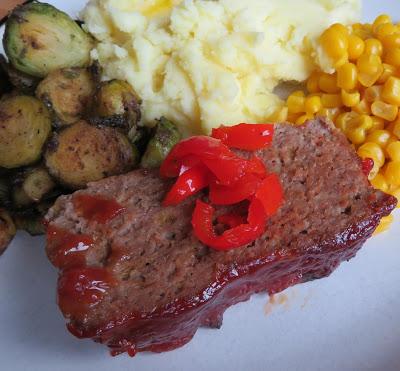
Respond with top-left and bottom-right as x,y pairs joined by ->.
3,2 -> 93,77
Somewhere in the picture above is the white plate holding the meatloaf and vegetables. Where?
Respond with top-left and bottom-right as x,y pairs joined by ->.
0,0 -> 400,371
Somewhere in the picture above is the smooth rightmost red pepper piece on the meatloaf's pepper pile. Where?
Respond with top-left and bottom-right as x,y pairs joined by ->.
256,174 -> 284,216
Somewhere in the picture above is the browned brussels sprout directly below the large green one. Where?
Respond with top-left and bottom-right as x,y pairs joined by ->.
36,67 -> 95,126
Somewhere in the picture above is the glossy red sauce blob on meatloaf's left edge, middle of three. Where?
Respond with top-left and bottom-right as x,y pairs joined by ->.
47,225 -> 94,269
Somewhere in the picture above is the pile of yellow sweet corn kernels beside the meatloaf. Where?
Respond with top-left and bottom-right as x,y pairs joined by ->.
283,15 -> 400,232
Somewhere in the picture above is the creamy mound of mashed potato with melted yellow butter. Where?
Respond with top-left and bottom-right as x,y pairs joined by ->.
82,0 -> 361,133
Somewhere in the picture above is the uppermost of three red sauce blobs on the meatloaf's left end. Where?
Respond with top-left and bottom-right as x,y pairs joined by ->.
73,194 -> 125,224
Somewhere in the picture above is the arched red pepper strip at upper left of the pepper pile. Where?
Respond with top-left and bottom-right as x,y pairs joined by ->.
160,136 -> 236,178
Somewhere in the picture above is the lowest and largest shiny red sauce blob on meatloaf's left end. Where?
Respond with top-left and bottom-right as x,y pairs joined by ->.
57,267 -> 114,318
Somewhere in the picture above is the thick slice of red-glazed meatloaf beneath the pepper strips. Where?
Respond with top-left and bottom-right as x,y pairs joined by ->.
47,119 -> 396,355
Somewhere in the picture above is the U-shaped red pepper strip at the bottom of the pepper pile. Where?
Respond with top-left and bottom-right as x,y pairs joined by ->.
192,199 -> 266,251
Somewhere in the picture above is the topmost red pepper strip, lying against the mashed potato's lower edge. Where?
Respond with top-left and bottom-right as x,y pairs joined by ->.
211,124 -> 274,151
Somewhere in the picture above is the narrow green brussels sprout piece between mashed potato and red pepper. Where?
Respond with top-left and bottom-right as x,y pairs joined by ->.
141,117 -> 182,169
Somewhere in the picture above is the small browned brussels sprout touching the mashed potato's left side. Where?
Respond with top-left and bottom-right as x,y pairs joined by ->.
93,80 -> 142,133
